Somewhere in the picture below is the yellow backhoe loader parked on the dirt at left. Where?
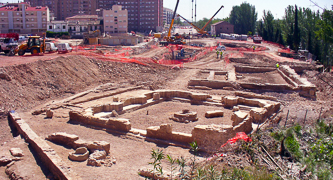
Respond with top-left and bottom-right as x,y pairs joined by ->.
15,33 -> 45,56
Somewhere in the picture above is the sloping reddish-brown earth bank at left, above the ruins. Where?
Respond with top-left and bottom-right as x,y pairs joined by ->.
0,56 -> 178,112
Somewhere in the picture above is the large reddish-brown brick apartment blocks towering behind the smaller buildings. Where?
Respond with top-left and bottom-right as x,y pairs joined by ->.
25,0 -> 163,32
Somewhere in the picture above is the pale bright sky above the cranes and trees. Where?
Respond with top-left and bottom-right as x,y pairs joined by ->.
163,0 -> 333,21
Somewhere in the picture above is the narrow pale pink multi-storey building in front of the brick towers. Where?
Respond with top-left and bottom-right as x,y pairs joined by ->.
103,5 -> 128,34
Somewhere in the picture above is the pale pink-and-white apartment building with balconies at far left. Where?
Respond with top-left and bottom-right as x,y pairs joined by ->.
0,2 -> 50,34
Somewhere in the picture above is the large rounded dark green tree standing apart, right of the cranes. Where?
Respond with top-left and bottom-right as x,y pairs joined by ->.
229,2 -> 258,34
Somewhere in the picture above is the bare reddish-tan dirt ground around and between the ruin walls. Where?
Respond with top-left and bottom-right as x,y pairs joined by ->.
0,38 -> 333,179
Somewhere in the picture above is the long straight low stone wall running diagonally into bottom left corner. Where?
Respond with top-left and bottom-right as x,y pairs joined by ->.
9,112 -> 81,180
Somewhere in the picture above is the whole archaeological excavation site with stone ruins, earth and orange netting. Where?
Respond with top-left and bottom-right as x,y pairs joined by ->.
0,38 -> 333,180
